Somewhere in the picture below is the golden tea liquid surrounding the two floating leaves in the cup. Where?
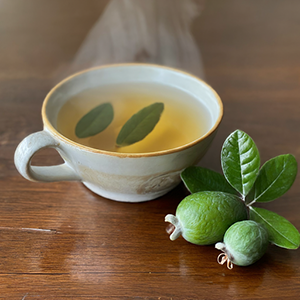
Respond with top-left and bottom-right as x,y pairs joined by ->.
57,83 -> 211,153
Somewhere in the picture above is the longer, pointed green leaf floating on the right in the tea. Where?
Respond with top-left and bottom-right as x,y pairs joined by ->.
116,102 -> 164,147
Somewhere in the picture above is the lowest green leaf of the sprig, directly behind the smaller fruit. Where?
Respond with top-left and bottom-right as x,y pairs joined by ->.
250,207 -> 300,249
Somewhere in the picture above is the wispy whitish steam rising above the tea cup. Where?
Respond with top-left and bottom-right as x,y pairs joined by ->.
67,0 -> 204,78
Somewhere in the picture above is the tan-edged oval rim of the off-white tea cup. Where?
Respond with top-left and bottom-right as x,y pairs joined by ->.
42,63 -> 223,158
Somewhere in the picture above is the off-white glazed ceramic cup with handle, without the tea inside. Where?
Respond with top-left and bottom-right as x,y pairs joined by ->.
15,64 -> 223,202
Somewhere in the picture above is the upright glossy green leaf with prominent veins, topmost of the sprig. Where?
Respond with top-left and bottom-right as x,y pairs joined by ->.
221,130 -> 260,198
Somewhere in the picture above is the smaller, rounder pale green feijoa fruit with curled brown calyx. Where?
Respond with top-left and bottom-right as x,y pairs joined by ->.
215,220 -> 269,269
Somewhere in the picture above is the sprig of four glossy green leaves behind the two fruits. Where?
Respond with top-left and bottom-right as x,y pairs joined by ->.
181,130 -> 300,249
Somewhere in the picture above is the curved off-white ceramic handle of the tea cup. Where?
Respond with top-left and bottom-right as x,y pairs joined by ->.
14,131 -> 81,182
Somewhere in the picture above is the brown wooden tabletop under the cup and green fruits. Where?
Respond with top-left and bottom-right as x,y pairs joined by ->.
0,0 -> 300,300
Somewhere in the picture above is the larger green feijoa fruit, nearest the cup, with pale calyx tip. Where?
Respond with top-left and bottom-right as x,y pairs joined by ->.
165,192 -> 247,245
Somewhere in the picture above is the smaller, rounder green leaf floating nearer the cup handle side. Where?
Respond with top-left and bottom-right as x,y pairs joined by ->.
75,103 -> 114,138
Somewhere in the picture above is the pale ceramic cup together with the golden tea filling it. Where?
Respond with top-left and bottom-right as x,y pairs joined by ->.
15,64 -> 223,202
